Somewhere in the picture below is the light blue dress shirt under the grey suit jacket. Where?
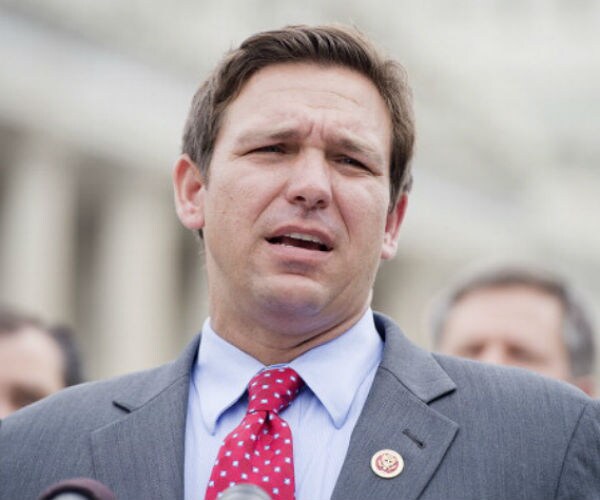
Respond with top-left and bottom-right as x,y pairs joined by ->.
184,309 -> 383,500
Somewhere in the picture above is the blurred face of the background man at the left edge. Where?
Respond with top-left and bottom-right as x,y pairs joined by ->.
0,327 -> 64,418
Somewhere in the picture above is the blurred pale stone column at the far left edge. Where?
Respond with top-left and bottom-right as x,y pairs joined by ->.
0,137 -> 77,322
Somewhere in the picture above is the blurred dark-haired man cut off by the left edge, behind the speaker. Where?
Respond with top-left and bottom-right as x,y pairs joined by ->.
0,307 -> 81,418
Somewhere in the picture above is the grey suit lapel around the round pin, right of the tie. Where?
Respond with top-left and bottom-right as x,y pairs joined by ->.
332,315 -> 458,500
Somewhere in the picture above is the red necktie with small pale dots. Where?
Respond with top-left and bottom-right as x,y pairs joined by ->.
205,368 -> 304,500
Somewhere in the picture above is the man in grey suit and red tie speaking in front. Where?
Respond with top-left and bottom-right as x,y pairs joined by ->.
0,26 -> 600,500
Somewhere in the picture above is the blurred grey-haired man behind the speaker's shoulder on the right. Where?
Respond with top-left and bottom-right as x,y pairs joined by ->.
431,266 -> 596,396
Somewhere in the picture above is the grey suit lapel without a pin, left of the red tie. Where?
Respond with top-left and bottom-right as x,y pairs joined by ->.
91,338 -> 199,500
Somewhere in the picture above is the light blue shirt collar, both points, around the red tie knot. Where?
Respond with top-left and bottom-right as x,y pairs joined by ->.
193,309 -> 383,434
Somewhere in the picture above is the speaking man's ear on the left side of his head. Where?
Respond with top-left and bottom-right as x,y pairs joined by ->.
173,155 -> 206,230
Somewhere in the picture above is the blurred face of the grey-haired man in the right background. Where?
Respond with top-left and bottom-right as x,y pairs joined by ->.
439,285 -> 570,381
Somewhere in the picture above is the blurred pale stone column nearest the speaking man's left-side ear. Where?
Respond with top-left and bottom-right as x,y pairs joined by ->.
91,173 -> 180,377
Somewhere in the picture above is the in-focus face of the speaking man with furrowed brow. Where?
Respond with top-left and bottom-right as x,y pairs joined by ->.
178,64 -> 405,336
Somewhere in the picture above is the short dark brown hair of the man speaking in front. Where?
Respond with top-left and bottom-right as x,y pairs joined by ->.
182,26 -> 414,208
